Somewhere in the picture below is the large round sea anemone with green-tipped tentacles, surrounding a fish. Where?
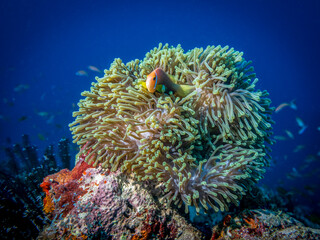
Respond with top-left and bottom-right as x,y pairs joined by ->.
70,44 -> 272,212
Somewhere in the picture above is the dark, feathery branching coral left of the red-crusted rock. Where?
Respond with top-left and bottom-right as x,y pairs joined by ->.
0,135 -> 69,239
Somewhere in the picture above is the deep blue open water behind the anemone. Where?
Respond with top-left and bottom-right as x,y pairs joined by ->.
0,0 -> 320,210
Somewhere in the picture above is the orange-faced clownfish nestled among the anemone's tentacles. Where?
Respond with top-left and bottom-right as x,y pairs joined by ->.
145,68 -> 195,97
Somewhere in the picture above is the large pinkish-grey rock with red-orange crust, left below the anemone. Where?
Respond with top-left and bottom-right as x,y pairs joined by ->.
38,160 -> 203,240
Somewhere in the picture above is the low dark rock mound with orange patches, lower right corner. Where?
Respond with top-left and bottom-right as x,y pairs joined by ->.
211,209 -> 320,240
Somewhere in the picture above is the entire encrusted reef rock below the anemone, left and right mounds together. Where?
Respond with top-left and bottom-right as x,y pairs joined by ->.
38,160 -> 320,240
